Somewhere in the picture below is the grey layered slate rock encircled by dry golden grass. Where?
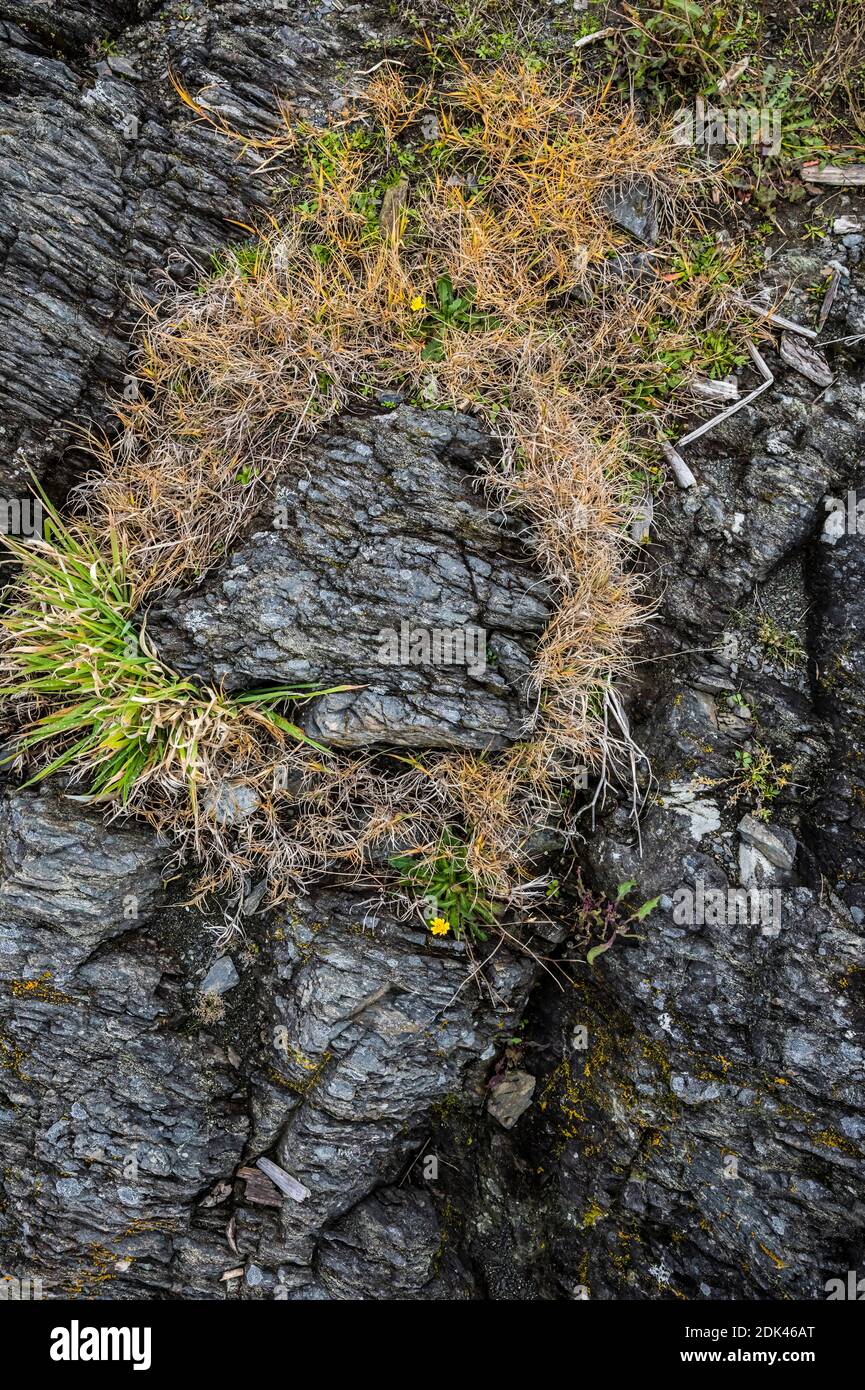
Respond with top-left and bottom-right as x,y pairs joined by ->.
149,406 -> 549,748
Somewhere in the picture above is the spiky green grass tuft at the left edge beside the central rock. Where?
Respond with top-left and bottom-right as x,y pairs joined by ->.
0,499 -> 345,806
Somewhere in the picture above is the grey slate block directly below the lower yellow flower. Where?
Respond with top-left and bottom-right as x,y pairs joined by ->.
230,892 -> 535,1298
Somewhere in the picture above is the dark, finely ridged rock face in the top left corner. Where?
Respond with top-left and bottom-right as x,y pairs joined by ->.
0,0 -> 403,495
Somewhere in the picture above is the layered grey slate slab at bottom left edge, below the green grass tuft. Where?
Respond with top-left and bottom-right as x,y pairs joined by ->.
0,792 -> 249,1298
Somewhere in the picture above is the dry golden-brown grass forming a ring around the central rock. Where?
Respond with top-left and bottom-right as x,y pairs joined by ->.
1,56 -> 750,906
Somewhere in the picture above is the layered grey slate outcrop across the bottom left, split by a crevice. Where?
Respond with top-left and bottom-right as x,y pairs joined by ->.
0,791 -> 535,1298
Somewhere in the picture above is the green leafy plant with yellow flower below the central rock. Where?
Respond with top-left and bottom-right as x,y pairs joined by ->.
391,827 -> 499,941
